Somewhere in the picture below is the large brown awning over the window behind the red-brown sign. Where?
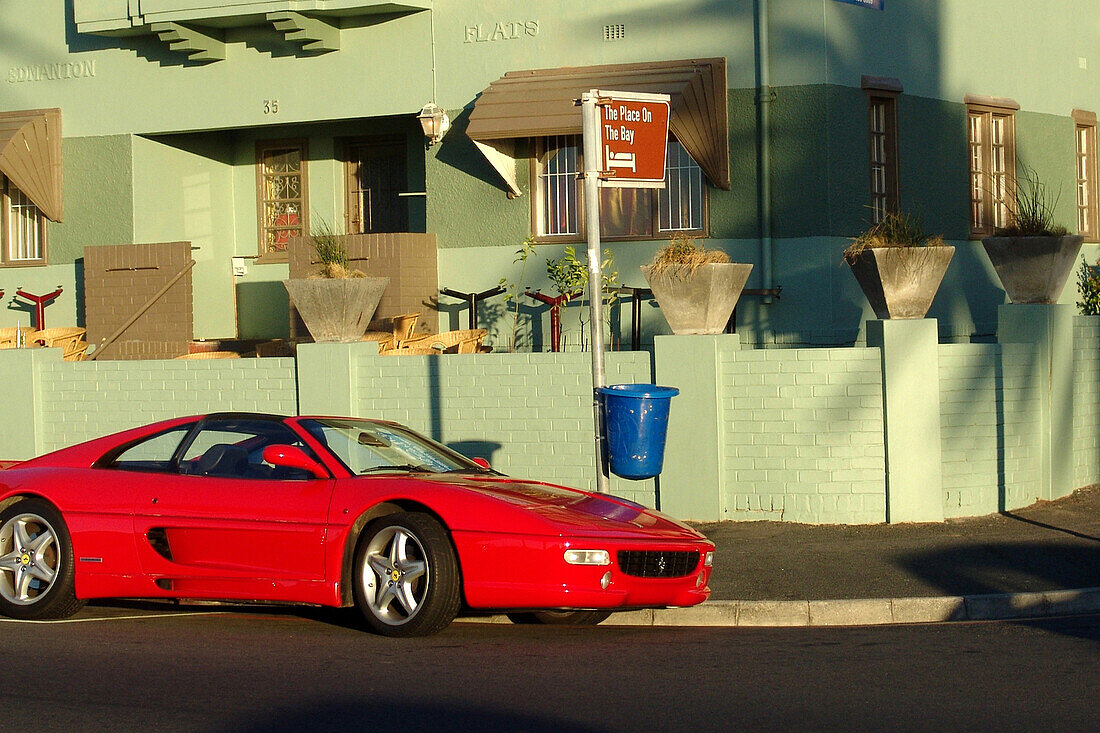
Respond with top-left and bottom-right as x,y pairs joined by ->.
466,58 -> 729,194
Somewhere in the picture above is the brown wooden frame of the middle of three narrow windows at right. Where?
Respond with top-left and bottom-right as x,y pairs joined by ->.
965,95 -> 1020,240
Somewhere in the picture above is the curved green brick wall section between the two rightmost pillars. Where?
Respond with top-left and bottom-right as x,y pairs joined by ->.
939,343 -> 1040,517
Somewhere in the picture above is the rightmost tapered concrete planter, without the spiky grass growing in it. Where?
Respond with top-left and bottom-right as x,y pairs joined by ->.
981,234 -> 1085,305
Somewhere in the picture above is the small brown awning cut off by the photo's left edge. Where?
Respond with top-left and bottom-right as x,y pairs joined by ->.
0,109 -> 62,221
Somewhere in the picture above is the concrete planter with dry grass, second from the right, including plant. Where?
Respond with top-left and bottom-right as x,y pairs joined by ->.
844,211 -> 955,319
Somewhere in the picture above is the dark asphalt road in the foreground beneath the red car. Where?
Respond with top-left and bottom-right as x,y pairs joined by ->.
0,606 -> 1100,732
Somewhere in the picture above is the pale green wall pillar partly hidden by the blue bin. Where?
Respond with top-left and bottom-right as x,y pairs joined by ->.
653,333 -> 740,522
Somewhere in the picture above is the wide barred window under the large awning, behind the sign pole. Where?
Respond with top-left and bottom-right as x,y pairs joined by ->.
532,135 -> 706,240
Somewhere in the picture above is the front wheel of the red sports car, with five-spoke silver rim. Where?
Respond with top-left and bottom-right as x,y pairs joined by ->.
352,512 -> 462,636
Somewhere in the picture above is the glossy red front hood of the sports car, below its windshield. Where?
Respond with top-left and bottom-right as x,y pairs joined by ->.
415,474 -> 705,540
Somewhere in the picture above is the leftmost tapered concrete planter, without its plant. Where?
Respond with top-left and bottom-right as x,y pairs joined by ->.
283,277 -> 389,342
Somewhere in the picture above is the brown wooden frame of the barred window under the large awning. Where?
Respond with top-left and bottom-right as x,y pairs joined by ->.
530,135 -> 711,243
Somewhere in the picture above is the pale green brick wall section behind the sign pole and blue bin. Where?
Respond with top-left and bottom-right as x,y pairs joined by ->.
352,352 -> 656,506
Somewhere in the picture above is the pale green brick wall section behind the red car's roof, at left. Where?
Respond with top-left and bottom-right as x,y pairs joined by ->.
40,357 -> 298,451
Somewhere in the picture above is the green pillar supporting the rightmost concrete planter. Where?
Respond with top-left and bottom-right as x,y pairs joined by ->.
997,304 -> 1076,500
